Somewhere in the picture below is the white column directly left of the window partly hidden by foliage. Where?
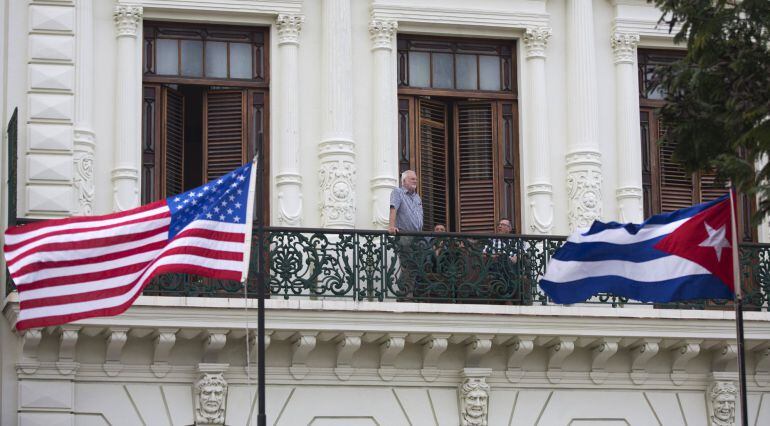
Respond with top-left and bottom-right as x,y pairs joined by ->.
610,32 -> 644,223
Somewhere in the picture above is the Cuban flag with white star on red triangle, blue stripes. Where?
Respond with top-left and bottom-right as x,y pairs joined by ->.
540,194 -> 735,304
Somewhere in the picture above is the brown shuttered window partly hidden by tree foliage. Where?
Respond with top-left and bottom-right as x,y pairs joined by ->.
638,50 -> 756,241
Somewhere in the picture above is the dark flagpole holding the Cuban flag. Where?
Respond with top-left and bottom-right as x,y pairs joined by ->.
730,185 -> 749,426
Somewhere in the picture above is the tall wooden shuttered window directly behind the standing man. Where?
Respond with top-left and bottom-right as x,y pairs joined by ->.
398,36 -> 519,232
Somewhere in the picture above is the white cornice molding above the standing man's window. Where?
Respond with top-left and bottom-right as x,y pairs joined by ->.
372,0 -> 549,29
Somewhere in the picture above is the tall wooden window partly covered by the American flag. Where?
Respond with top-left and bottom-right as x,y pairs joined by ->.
142,22 -> 269,223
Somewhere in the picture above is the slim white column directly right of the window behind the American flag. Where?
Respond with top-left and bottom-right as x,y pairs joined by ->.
275,15 -> 305,226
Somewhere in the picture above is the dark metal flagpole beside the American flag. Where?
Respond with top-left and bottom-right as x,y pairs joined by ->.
256,143 -> 267,426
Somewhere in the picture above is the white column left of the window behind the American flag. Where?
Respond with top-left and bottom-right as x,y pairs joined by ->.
112,6 -> 142,211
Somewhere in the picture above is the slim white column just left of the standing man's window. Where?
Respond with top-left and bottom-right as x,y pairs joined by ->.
369,19 -> 398,229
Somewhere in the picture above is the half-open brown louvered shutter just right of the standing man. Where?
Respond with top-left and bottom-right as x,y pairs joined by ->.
417,99 -> 449,231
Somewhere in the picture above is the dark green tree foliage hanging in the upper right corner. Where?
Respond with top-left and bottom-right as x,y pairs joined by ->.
648,0 -> 770,220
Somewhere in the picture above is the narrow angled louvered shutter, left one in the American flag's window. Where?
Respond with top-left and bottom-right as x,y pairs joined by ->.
161,87 -> 185,197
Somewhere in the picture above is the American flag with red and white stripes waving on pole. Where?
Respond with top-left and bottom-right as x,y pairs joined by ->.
5,163 -> 254,330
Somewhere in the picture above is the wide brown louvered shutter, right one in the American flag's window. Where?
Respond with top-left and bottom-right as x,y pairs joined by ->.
203,90 -> 246,182
